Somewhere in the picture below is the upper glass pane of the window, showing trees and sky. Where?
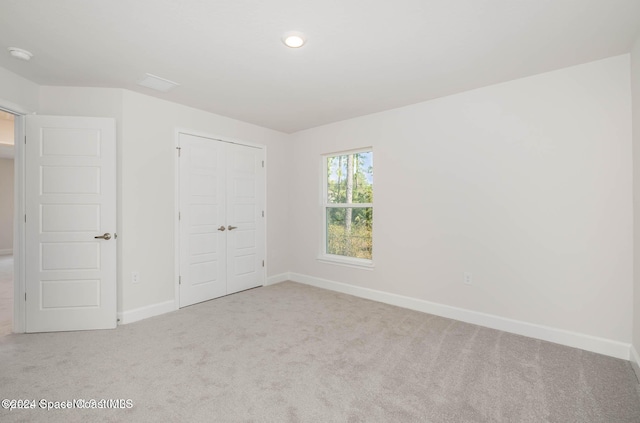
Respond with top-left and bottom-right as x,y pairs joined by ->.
327,151 -> 373,204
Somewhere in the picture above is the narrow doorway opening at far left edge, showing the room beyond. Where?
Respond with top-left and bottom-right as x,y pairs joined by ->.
0,110 -> 15,336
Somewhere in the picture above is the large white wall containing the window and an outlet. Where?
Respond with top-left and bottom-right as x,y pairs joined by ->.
290,55 -> 633,344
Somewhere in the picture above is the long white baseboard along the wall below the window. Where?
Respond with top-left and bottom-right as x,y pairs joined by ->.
289,273 -> 631,360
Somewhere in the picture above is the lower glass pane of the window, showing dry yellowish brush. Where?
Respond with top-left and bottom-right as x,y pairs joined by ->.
327,207 -> 373,260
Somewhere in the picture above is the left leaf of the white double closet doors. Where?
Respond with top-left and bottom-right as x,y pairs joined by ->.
178,134 -> 227,307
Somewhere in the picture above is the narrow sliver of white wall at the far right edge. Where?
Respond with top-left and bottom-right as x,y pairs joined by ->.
631,35 -> 640,366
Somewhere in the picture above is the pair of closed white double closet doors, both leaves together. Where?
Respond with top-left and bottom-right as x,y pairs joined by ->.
178,133 -> 265,307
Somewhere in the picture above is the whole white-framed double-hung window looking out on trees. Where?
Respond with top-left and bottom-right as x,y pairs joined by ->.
320,149 -> 373,266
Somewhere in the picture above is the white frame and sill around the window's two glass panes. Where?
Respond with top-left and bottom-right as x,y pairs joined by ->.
317,147 -> 375,270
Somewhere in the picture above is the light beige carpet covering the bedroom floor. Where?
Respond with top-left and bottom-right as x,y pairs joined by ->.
0,282 -> 640,423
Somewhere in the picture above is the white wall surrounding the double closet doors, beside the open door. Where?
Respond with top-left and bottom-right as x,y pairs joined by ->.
40,87 -> 289,313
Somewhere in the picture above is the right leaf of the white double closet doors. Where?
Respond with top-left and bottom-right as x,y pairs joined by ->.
227,144 -> 265,294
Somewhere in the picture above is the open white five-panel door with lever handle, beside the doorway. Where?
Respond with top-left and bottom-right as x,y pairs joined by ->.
25,116 -> 117,332
